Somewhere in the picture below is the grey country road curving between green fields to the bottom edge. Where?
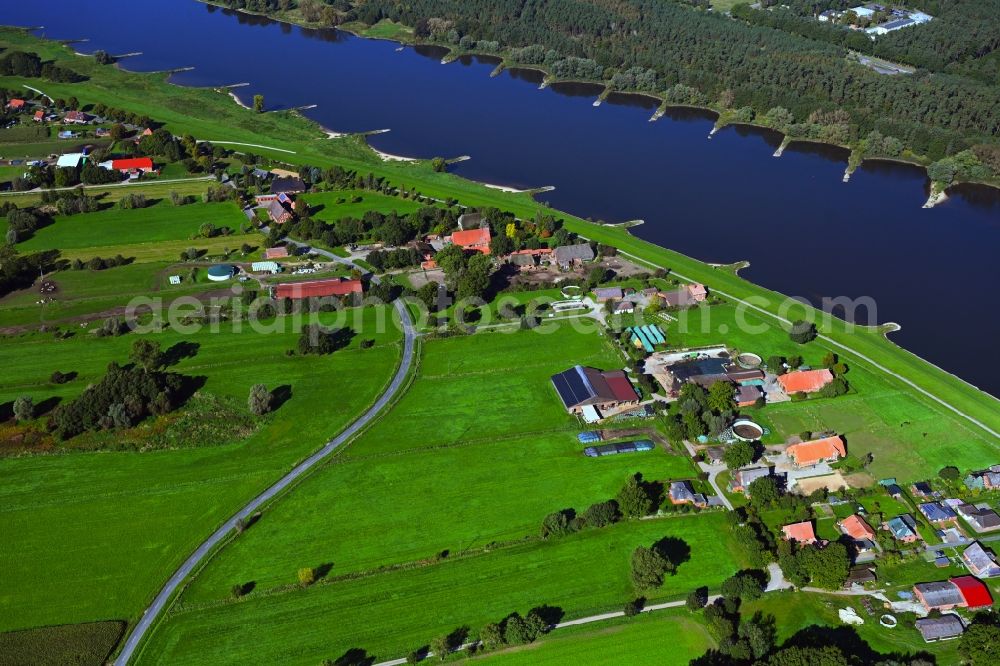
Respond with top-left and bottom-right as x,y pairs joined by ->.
115,300 -> 416,666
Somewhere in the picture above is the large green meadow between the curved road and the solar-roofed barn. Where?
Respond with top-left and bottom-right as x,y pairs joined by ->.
176,327 -> 696,602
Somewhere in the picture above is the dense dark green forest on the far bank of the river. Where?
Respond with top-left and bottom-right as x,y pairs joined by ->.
209,0 -> 1000,166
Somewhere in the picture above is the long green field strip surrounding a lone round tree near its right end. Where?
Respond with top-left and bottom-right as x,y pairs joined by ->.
146,513 -> 739,664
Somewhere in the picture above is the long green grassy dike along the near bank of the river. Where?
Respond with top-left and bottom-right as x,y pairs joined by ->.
0,28 -> 1000,437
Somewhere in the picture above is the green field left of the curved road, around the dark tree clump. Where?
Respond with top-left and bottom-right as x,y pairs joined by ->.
0,308 -> 400,630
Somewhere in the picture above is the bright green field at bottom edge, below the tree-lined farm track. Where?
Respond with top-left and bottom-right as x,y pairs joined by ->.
462,609 -> 713,666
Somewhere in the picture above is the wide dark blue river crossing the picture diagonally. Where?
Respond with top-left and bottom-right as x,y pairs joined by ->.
0,0 -> 1000,395
